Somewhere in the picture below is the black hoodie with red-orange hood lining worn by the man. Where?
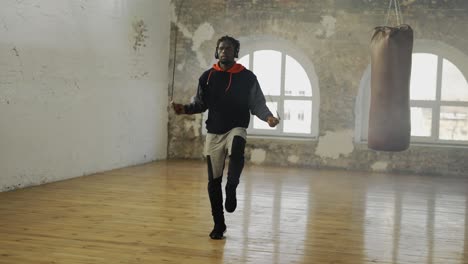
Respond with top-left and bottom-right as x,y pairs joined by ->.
185,63 -> 273,134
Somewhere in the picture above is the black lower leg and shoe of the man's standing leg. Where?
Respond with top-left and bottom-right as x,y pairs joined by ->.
208,177 -> 226,239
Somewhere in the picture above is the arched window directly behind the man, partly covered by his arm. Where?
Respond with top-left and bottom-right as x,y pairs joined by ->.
237,38 -> 320,137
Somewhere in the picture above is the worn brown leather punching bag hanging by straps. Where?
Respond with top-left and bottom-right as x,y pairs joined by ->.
368,0 -> 413,151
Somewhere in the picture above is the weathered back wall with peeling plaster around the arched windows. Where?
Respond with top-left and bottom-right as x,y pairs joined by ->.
168,0 -> 468,176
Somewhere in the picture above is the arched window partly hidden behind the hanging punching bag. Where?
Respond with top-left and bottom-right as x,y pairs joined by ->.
356,40 -> 468,144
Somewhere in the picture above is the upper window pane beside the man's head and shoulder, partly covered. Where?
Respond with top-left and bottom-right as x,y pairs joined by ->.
253,50 -> 281,95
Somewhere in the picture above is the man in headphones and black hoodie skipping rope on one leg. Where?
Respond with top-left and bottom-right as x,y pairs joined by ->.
172,36 -> 279,239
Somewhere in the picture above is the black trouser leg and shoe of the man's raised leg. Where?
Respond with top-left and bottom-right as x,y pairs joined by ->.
224,136 -> 245,213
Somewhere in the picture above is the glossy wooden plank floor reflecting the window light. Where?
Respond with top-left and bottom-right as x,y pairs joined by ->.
0,161 -> 468,264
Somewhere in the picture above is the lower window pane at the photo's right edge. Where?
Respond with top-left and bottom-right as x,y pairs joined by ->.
439,106 -> 468,140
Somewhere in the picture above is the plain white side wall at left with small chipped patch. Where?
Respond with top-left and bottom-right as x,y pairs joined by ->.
0,0 -> 170,191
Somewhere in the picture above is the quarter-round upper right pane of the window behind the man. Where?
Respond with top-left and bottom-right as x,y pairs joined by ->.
284,55 -> 312,96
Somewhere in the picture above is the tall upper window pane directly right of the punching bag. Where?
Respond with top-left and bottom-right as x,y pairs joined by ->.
410,53 -> 437,100
